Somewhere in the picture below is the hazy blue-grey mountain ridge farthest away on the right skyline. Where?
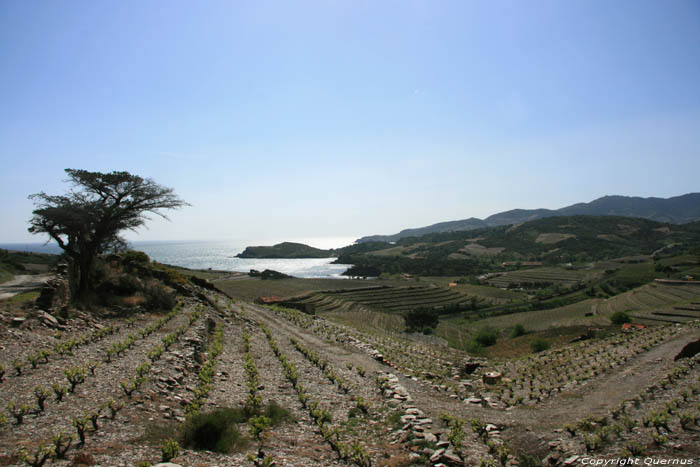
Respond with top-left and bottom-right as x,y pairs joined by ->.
357,193 -> 700,243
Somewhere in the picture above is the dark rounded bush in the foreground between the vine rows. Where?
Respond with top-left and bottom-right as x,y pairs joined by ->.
182,408 -> 246,454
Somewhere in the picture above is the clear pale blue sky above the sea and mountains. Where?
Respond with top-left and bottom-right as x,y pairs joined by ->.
0,0 -> 700,246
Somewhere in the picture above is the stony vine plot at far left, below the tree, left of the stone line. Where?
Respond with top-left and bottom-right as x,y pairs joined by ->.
0,296 -> 211,464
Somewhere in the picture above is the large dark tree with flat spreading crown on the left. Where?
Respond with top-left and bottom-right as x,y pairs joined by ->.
29,169 -> 188,297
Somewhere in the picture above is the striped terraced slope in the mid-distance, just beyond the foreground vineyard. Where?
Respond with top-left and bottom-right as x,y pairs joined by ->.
290,286 -> 477,313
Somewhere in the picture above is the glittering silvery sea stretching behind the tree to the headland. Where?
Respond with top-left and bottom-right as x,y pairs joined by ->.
0,239 -> 353,279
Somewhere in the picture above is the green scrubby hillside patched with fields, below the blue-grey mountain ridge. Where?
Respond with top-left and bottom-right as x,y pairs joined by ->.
337,216 -> 700,276
